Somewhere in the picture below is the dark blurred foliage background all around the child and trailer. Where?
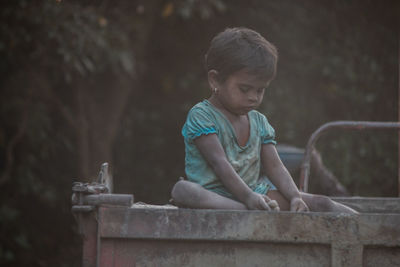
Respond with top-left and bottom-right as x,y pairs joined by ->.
0,0 -> 400,266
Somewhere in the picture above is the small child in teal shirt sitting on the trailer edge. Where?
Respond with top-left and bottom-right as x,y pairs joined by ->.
172,28 -> 357,213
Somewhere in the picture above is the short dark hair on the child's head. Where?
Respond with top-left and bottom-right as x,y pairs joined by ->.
205,27 -> 278,82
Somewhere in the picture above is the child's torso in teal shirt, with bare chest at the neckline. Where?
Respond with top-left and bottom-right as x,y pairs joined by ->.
182,101 -> 270,198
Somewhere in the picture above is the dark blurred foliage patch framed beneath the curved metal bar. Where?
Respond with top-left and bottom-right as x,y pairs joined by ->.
318,130 -> 398,197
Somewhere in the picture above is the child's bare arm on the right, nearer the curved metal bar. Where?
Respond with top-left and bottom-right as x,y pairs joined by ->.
261,144 -> 308,211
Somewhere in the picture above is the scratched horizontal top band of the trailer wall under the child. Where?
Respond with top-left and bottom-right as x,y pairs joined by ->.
99,208 -> 400,246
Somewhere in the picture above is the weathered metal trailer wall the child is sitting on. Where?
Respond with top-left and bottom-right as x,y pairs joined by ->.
76,198 -> 400,267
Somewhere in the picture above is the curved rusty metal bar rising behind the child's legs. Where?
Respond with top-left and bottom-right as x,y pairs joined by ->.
299,121 -> 400,192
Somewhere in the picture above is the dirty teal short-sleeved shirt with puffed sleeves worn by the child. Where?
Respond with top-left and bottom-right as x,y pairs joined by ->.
182,100 -> 276,199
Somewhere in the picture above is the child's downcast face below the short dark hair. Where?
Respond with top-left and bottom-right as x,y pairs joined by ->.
212,69 -> 270,115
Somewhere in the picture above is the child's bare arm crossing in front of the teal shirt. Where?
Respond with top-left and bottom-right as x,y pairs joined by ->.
194,134 -> 271,210
